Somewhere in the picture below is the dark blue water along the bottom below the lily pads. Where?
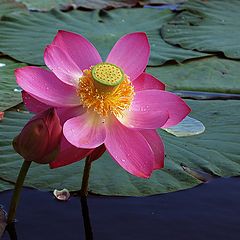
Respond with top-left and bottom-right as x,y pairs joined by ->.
0,178 -> 240,240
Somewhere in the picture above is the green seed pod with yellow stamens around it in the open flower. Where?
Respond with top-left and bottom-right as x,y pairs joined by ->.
77,63 -> 134,118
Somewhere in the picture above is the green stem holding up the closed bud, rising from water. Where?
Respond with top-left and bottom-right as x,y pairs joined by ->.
7,161 -> 31,224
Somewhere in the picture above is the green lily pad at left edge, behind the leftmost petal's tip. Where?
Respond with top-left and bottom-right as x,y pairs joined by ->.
0,57 -> 26,111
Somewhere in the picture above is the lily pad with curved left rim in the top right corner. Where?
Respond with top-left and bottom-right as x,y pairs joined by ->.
162,0 -> 240,59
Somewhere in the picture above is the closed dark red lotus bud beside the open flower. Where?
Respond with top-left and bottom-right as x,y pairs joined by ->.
13,108 -> 62,164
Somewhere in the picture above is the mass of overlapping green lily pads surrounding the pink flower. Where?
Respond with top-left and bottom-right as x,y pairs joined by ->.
0,0 -> 240,196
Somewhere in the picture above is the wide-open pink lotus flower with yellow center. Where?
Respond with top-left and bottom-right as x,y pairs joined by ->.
15,31 -> 190,178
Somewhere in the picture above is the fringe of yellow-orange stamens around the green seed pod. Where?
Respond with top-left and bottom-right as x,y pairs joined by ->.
77,65 -> 134,118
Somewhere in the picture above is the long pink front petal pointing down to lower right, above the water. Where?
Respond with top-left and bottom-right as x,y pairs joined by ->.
105,119 -> 154,178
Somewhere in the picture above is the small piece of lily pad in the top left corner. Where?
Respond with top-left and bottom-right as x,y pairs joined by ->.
0,0 -> 27,19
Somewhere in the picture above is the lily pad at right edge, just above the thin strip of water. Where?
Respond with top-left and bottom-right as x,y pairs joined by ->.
147,57 -> 240,93
